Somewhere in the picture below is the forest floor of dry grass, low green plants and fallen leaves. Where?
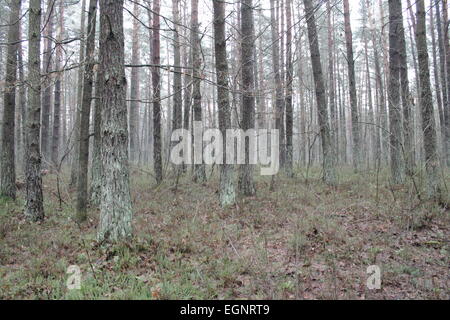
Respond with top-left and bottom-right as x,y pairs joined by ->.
0,169 -> 450,299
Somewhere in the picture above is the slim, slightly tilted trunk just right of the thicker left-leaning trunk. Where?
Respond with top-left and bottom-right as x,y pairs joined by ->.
344,0 -> 362,171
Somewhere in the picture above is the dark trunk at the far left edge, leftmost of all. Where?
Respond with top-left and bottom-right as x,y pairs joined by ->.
0,0 -> 21,200
